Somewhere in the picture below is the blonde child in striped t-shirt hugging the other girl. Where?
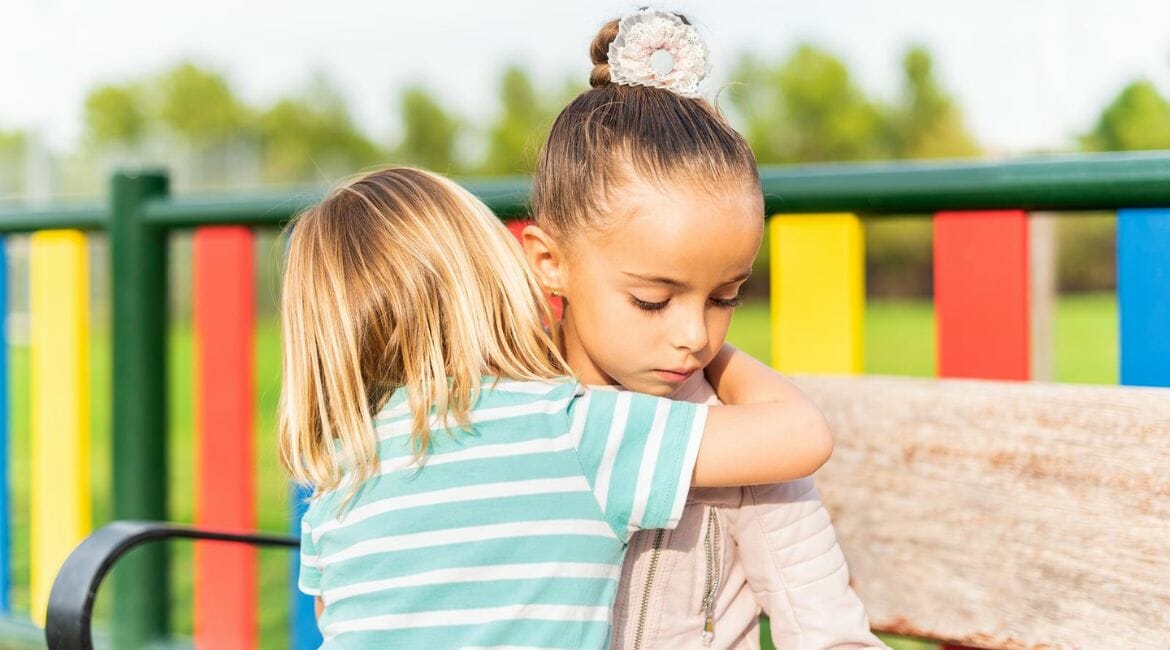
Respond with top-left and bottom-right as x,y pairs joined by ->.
280,168 -> 832,648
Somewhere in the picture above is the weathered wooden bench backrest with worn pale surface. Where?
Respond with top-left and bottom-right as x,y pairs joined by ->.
798,376 -> 1170,648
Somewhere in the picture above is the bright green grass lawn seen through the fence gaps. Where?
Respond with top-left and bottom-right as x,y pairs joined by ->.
0,295 -> 1117,650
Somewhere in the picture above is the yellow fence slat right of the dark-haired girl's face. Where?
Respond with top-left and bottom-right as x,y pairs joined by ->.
769,214 -> 865,374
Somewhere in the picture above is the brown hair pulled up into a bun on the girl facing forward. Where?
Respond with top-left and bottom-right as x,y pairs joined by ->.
532,15 -> 759,237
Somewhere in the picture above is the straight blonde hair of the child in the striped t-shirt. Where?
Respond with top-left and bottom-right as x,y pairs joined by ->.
280,167 -> 569,503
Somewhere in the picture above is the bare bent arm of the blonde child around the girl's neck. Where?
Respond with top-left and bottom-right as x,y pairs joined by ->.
691,345 -> 833,488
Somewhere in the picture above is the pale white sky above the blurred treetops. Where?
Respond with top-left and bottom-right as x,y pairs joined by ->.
0,0 -> 1170,155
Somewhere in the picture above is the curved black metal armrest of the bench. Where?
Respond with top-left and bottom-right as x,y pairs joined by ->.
44,521 -> 301,650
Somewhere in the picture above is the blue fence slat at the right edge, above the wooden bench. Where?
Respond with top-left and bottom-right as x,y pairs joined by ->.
1117,209 -> 1170,387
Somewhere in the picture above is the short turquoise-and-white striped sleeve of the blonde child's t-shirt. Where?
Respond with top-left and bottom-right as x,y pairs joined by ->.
569,389 -> 708,540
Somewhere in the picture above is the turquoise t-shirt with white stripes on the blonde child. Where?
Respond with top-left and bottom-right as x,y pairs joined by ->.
300,381 -> 707,649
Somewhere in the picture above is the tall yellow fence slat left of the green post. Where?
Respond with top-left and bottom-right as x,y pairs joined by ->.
29,230 -> 92,625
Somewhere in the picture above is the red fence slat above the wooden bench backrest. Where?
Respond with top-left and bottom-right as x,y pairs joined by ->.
934,210 -> 1032,380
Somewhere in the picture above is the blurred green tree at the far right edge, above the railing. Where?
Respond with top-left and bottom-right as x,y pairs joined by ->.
1081,79 -> 1170,151
